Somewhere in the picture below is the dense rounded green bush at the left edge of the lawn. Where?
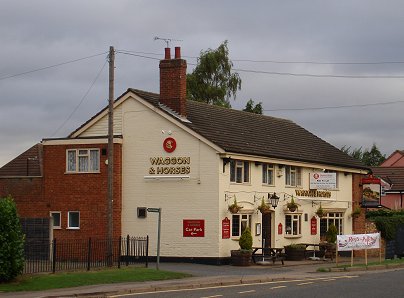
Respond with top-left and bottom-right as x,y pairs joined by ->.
0,196 -> 24,282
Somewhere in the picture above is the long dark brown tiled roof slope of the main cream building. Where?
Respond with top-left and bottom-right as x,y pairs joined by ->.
128,89 -> 367,169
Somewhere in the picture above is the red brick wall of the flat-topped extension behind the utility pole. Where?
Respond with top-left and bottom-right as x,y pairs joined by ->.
43,144 -> 122,239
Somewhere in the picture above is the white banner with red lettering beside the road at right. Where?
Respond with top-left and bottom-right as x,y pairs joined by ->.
337,233 -> 380,251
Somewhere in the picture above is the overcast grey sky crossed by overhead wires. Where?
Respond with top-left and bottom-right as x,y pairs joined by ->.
0,0 -> 404,166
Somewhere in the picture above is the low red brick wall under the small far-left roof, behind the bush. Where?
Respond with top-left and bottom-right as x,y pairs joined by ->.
0,177 -> 44,217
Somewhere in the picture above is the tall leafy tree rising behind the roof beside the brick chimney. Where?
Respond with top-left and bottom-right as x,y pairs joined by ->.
187,40 -> 241,108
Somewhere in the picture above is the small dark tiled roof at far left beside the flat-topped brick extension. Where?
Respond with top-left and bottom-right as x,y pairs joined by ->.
0,144 -> 42,177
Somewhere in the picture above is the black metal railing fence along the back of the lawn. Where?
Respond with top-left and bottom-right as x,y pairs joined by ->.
24,235 -> 149,274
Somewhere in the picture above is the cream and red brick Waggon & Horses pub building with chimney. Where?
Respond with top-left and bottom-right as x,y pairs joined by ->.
0,48 -> 368,264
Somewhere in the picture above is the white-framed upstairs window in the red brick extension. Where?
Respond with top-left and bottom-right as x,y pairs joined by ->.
66,149 -> 100,173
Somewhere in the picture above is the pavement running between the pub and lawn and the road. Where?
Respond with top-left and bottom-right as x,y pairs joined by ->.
0,258 -> 404,298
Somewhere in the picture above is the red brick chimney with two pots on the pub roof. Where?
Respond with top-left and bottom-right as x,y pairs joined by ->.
160,47 -> 187,117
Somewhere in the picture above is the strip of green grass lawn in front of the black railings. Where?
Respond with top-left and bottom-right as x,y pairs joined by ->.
0,268 -> 190,292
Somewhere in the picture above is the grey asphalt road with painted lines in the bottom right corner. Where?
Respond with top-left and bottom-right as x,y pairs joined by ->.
108,270 -> 404,298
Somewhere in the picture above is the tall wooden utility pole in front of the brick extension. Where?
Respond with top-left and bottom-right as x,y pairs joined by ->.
107,46 -> 115,266
